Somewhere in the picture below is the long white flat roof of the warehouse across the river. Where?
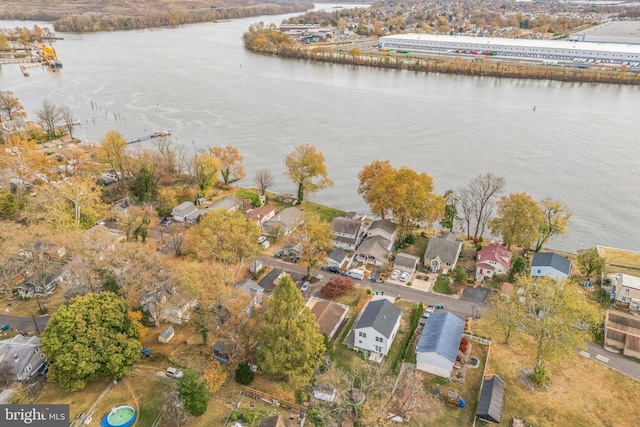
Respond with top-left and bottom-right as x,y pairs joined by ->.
380,33 -> 640,54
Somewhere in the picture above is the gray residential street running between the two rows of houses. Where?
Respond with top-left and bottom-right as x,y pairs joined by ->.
260,256 -> 487,319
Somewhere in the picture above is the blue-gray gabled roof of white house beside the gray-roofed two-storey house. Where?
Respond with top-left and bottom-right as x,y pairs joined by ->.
416,311 -> 464,363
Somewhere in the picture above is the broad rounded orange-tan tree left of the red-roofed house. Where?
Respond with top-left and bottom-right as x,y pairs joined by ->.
187,209 -> 263,277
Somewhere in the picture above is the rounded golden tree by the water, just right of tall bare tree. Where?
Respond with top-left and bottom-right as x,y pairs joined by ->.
489,193 -> 543,249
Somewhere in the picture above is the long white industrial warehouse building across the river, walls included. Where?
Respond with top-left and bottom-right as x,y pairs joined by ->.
379,34 -> 640,67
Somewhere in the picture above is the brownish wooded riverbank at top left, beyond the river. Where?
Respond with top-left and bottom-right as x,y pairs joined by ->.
0,0 -> 313,32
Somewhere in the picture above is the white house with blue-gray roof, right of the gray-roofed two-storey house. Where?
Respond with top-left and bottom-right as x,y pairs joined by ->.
416,311 -> 464,378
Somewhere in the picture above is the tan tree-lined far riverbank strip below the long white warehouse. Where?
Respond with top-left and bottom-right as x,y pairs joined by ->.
251,44 -> 640,85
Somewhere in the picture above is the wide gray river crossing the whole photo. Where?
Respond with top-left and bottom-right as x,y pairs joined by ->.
0,5 -> 640,252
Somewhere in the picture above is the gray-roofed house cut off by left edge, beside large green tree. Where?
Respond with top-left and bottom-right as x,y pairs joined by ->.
0,334 -> 47,384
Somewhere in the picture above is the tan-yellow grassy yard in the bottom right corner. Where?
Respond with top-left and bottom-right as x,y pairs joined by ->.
473,316 -> 640,427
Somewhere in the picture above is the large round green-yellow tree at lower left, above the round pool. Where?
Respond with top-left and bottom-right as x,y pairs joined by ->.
40,292 -> 142,391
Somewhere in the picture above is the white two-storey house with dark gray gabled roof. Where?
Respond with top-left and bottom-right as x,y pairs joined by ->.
344,297 -> 402,356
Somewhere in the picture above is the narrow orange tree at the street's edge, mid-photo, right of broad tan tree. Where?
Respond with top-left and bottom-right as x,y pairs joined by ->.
292,214 -> 334,280
